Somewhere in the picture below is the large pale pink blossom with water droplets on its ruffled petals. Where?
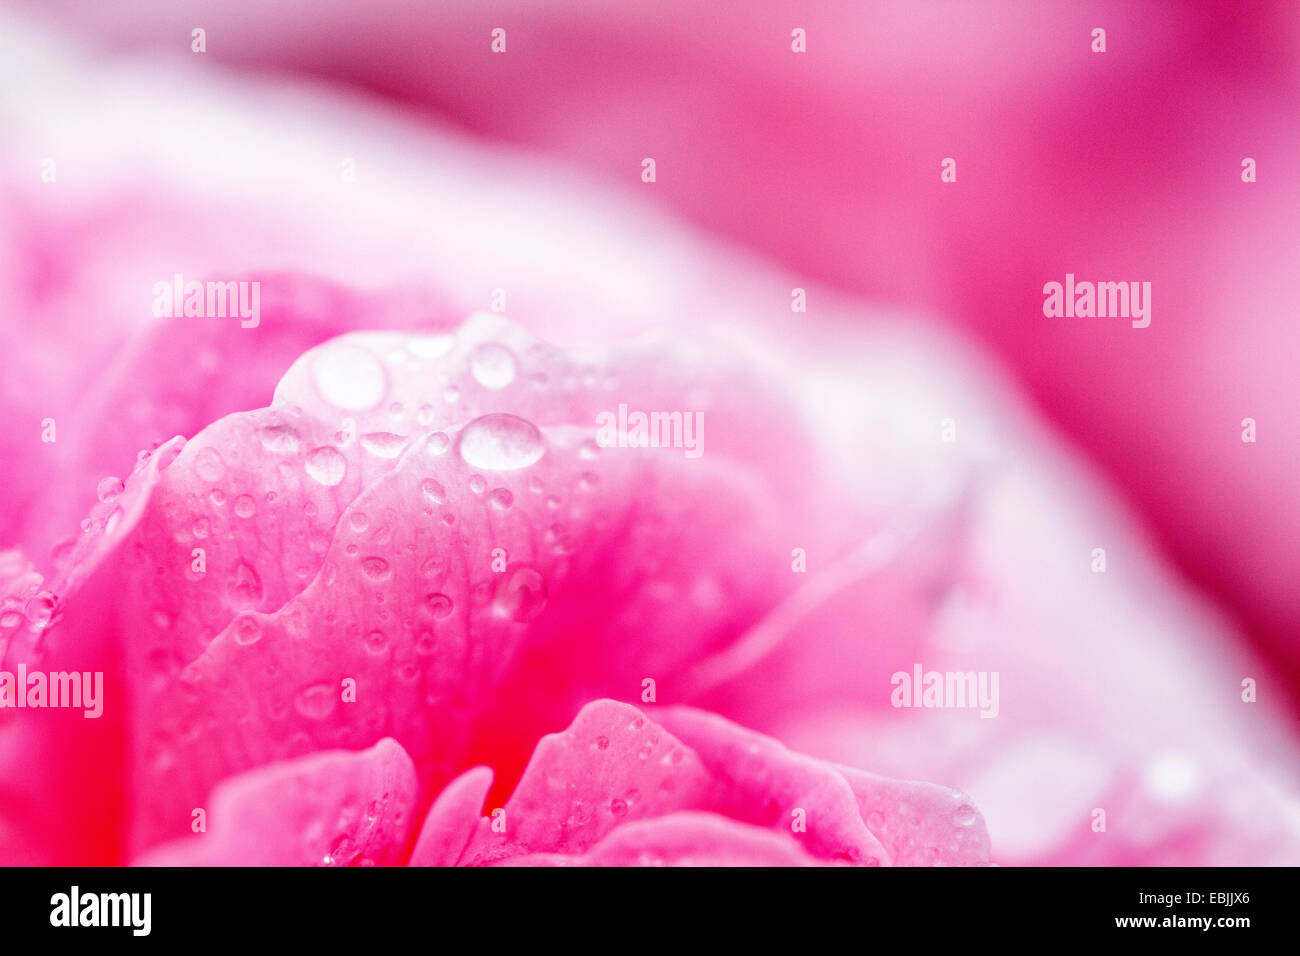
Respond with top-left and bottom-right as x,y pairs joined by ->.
0,7 -> 1300,865
